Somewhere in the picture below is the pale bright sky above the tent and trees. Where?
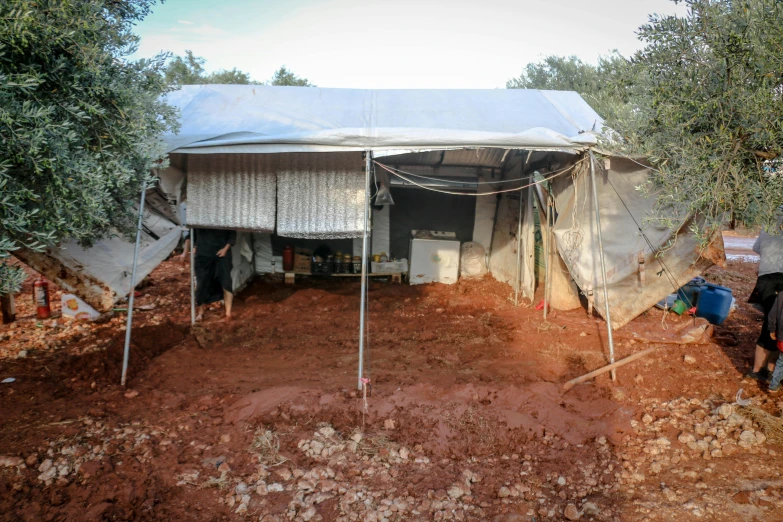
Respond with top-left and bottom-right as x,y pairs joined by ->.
132,0 -> 685,89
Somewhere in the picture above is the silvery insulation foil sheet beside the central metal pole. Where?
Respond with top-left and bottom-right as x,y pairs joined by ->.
277,152 -> 364,239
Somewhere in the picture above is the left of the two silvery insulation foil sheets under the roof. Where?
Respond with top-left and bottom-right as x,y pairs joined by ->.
187,154 -> 277,232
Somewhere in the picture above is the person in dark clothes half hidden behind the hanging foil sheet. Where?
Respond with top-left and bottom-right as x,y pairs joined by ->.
193,228 -> 236,320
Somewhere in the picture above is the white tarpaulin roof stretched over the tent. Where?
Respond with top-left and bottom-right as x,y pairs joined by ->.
165,85 -> 603,154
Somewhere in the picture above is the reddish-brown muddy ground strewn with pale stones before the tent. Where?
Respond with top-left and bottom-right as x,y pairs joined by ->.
0,254 -> 783,522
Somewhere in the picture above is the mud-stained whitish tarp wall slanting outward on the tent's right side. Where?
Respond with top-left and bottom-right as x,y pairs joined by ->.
552,154 -> 724,328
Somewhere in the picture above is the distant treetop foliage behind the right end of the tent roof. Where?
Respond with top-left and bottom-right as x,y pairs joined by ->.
506,51 -> 630,119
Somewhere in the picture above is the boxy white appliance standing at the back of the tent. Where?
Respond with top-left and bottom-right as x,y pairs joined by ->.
408,230 -> 460,285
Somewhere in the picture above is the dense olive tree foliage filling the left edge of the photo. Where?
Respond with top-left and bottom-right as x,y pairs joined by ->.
0,0 -> 176,293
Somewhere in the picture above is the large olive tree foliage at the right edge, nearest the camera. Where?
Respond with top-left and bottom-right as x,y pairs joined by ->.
607,0 -> 783,237
